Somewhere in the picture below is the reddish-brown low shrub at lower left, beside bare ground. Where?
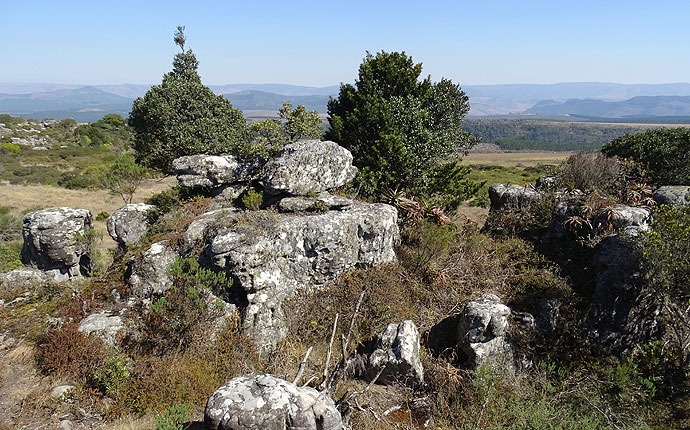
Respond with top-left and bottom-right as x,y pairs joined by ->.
36,323 -> 105,382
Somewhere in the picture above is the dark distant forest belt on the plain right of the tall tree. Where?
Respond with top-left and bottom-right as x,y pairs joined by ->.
462,118 -> 661,151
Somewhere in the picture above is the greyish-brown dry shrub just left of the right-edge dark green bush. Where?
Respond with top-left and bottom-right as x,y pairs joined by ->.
558,152 -> 624,194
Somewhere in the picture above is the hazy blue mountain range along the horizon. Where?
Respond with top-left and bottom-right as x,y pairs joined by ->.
0,82 -> 690,122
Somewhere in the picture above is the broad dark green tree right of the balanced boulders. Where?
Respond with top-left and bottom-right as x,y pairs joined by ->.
326,51 -> 476,202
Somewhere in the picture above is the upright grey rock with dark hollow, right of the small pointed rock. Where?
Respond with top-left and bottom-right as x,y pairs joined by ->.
458,293 -> 514,370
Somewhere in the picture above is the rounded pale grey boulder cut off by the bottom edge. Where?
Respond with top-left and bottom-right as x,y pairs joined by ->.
204,374 -> 343,430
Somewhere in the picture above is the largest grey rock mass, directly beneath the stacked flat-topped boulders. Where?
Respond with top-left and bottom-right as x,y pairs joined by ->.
205,203 -> 400,352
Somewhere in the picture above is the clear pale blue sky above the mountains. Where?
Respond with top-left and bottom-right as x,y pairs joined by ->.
0,0 -> 690,86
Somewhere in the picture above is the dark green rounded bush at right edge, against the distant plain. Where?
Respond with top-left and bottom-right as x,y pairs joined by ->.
602,128 -> 690,185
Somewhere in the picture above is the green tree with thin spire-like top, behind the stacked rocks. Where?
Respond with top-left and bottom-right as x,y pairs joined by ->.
129,27 -> 252,173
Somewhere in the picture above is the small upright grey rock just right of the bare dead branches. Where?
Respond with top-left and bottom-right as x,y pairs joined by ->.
367,320 -> 424,386
